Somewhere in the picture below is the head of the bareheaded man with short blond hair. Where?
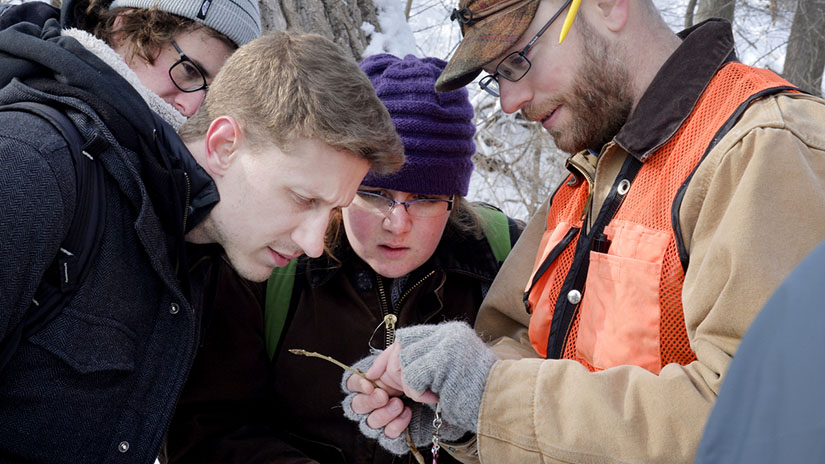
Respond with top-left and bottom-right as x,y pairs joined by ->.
179,32 -> 404,281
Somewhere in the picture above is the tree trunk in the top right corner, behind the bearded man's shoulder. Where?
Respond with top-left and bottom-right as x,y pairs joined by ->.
782,0 -> 825,95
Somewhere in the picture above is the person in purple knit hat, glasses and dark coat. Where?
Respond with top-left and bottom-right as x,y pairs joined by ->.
162,54 -> 523,464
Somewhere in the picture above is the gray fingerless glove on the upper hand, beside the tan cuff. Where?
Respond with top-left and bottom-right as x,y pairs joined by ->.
395,322 -> 498,434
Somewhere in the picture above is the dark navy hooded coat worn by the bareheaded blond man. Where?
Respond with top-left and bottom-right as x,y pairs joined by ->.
0,10 -> 218,464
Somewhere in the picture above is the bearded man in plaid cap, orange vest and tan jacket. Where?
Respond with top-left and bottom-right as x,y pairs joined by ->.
345,0 -> 825,463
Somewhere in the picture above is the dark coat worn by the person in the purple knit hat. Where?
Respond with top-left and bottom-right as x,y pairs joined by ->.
167,215 -> 523,464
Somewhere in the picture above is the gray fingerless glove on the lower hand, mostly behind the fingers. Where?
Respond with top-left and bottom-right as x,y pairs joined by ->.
341,351 -> 466,456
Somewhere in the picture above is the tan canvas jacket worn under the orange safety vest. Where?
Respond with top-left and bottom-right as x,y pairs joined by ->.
453,19 -> 825,463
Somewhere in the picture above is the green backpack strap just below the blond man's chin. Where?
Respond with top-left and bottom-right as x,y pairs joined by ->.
264,259 -> 298,359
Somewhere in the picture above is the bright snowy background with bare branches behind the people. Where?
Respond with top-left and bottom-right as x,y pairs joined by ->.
8,0 -> 812,220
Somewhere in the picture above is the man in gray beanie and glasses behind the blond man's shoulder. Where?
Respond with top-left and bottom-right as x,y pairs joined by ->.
0,0 -> 261,125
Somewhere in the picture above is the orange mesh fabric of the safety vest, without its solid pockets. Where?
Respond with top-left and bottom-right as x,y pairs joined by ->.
530,63 -> 790,371
